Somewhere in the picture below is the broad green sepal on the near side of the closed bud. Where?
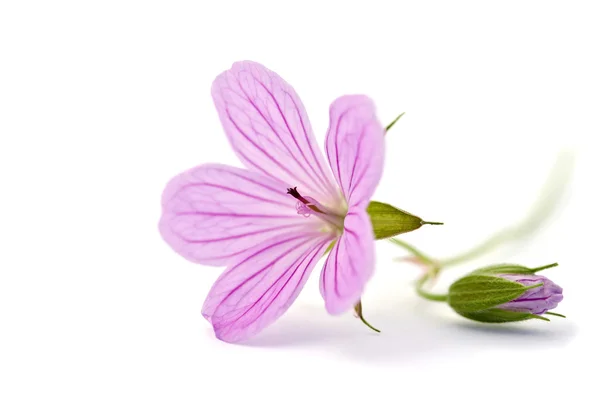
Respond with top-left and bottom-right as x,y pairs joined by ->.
448,274 -> 538,313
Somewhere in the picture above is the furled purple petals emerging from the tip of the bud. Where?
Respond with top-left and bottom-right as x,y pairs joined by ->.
497,274 -> 563,315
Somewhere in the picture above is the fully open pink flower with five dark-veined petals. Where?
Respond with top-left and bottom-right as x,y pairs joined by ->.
159,61 -> 384,342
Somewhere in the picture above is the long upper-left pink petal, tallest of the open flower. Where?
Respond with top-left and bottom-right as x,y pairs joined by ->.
212,61 -> 339,205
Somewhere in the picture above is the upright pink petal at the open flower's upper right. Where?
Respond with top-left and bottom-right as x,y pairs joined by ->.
325,95 -> 385,208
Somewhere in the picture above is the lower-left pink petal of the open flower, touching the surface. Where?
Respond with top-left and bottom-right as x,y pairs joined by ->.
202,232 -> 333,342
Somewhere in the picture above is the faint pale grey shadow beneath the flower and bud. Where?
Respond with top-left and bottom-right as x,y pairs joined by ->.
245,297 -> 576,362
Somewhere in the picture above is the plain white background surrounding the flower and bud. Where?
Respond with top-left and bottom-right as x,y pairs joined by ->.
0,0 -> 600,397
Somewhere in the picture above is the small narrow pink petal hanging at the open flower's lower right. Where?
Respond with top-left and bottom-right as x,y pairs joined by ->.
320,208 -> 375,314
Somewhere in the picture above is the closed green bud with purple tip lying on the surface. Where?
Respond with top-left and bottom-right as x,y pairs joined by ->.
448,263 -> 563,323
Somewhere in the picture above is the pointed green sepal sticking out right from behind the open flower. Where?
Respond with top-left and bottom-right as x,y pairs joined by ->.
367,201 -> 425,240
